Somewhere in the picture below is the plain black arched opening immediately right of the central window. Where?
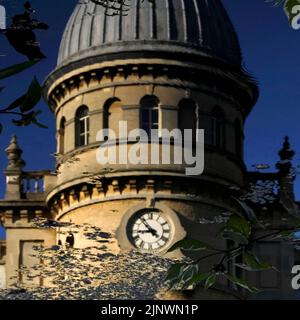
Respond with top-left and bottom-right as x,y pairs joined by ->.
178,99 -> 198,141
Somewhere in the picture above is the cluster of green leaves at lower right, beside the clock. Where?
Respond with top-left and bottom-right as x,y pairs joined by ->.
166,181 -> 300,293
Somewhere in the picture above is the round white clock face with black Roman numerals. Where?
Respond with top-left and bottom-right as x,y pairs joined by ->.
127,211 -> 172,251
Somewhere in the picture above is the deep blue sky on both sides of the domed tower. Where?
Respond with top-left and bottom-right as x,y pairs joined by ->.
0,0 -> 300,237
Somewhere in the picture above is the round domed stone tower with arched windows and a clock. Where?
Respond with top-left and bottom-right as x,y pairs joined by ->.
45,0 -> 258,252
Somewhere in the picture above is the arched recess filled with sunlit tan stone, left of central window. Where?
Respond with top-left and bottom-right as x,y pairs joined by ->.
103,98 -> 123,137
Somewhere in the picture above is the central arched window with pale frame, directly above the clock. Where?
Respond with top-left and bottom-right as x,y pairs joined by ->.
140,95 -> 159,134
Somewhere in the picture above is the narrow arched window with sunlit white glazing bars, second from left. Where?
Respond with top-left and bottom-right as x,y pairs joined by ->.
75,106 -> 90,147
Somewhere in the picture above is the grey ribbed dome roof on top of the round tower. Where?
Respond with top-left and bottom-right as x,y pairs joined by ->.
58,0 -> 242,66
